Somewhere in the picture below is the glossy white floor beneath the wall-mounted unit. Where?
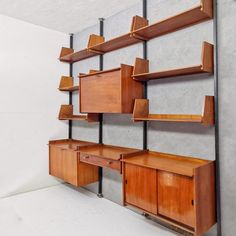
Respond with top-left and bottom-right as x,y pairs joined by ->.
0,184 -> 176,236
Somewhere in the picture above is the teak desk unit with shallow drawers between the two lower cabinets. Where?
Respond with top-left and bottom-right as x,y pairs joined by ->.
80,144 -> 140,172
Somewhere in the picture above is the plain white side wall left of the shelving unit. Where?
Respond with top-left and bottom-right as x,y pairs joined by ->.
0,15 -> 69,197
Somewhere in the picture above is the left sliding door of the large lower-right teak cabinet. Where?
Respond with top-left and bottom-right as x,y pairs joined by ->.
124,164 -> 157,214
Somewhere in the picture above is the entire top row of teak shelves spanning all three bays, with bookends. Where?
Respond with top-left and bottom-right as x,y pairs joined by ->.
59,0 -> 213,63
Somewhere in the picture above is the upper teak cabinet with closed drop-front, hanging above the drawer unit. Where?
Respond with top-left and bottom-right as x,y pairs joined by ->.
79,64 -> 143,113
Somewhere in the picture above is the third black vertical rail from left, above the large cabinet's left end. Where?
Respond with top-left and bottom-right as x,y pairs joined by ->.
143,0 -> 148,150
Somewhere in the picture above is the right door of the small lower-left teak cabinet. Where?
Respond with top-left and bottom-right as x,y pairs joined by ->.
62,150 -> 78,186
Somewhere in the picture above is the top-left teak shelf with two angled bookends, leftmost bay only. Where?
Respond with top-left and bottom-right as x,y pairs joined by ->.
59,34 -> 104,63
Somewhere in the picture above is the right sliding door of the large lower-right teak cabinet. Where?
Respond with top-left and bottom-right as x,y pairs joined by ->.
157,171 -> 194,227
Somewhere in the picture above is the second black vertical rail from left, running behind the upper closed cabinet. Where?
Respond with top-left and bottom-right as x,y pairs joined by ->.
97,18 -> 104,198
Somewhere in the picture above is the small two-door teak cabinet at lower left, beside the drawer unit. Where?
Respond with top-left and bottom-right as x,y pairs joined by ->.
49,139 -> 98,187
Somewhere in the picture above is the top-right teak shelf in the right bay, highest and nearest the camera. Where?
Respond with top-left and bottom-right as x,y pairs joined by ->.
132,0 -> 213,40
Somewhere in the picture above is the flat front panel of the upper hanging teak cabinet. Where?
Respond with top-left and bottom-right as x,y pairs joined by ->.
80,70 -> 121,113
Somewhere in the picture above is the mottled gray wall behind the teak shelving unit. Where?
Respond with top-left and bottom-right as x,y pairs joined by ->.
73,0 -> 236,236
